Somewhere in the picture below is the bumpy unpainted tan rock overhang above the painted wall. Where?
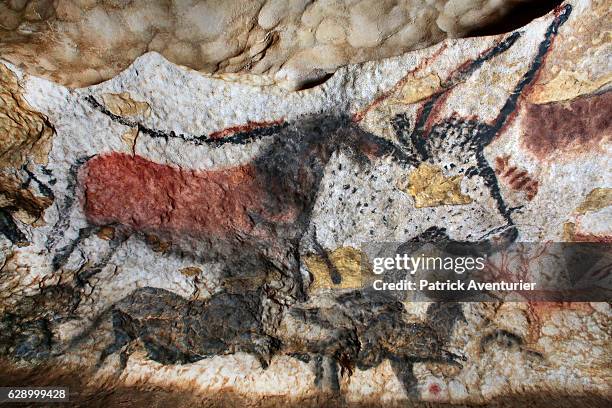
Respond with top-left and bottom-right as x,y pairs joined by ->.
0,0 -> 548,88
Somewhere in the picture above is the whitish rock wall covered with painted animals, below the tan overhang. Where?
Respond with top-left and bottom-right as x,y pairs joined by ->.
0,0 -> 612,406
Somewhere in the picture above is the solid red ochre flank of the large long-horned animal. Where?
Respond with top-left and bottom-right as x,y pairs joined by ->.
80,153 -> 292,235
